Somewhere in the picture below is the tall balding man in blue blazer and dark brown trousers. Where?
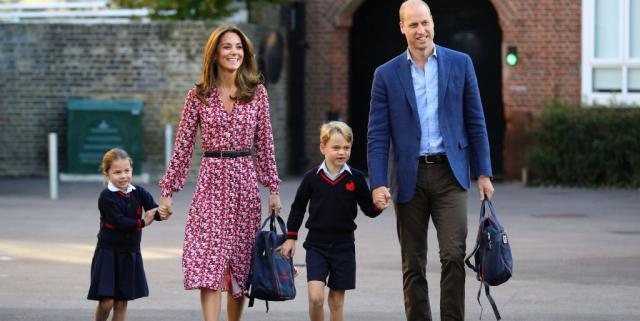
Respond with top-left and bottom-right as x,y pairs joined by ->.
367,0 -> 493,321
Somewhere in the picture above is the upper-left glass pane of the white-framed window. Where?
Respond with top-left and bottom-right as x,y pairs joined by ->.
595,0 -> 620,58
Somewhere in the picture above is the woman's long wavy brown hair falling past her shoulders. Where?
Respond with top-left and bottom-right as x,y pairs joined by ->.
196,26 -> 262,103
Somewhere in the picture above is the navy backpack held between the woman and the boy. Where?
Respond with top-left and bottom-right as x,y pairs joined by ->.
247,212 -> 296,312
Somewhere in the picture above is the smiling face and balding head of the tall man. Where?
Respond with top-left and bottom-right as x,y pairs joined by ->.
400,4 -> 435,51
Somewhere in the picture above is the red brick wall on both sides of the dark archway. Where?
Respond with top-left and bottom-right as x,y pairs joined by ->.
306,0 -> 581,178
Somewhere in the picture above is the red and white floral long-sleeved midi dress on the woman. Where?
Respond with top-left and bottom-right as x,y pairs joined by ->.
160,85 -> 280,298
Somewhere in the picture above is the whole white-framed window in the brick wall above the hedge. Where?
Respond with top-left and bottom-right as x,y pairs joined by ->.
582,0 -> 640,106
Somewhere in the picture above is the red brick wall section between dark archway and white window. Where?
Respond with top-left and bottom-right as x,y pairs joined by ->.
492,0 -> 581,178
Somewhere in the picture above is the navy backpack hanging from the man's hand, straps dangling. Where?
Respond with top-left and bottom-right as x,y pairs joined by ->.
465,196 -> 513,320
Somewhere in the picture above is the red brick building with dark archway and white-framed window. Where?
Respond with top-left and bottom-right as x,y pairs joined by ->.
305,0 -> 640,179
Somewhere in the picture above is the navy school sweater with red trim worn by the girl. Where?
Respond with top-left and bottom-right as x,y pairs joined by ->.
98,185 -> 160,251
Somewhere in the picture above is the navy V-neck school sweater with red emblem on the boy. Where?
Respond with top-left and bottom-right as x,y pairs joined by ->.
287,167 -> 381,243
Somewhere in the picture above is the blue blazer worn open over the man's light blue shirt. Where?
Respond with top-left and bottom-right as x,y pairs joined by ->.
367,46 -> 493,203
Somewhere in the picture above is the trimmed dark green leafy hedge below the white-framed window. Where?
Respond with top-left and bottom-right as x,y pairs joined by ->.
526,101 -> 640,188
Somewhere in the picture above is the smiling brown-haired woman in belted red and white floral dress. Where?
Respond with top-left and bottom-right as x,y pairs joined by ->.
160,26 -> 281,321
